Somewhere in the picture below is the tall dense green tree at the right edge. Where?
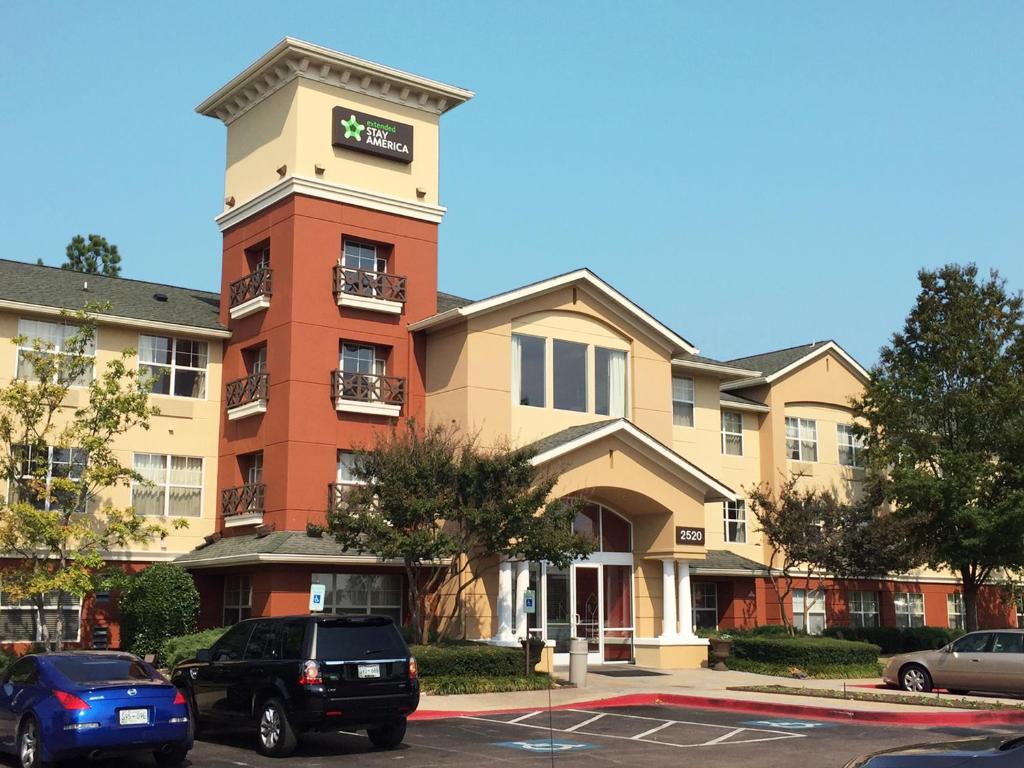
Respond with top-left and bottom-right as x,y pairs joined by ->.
855,264 -> 1024,630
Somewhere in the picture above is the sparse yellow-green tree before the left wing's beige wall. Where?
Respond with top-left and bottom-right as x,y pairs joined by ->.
0,307 -> 187,649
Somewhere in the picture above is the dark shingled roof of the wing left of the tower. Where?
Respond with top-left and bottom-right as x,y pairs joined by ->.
0,259 -> 226,331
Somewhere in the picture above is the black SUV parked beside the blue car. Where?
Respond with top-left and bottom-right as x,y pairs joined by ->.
171,615 -> 420,757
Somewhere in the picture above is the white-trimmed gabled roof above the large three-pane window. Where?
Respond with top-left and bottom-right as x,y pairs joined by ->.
409,268 -> 700,354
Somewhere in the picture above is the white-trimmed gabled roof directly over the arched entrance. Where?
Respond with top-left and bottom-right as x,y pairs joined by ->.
525,419 -> 737,502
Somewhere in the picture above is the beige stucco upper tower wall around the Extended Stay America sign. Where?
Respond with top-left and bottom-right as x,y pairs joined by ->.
224,78 -> 438,207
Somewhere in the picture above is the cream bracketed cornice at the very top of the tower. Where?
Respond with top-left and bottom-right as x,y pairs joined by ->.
196,37 -> 473,125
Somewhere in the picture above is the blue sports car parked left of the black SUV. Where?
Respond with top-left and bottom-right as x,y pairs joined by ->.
0,651 -> 193,768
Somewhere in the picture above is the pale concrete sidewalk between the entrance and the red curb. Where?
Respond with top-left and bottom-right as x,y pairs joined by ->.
420,666 -> 1024,723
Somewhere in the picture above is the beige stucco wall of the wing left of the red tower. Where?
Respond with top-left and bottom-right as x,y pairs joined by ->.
0,311 -> 222,560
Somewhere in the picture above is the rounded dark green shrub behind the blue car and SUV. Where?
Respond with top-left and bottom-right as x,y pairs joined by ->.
121,563 -> 199,656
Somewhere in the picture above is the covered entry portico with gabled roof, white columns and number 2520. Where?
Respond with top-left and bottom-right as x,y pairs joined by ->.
492,419 -> 734,668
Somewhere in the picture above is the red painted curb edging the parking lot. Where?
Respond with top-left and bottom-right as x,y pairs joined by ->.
410,693 -> 1024,727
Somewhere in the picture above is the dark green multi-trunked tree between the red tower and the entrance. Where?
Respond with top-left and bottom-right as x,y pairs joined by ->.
328,422 -> 594,642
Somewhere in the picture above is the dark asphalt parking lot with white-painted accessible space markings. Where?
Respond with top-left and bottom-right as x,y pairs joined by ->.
4,707 -> 1015,768
